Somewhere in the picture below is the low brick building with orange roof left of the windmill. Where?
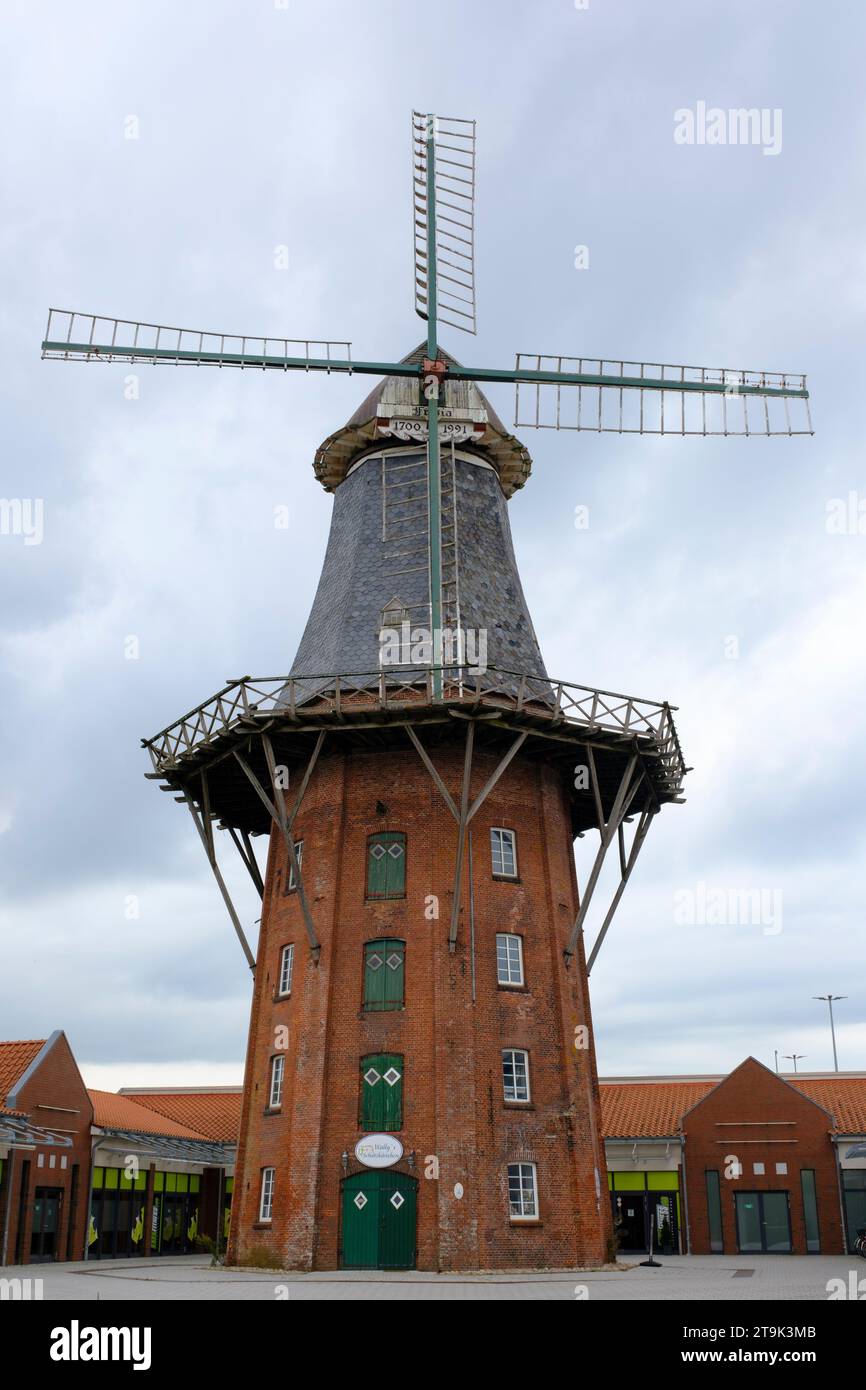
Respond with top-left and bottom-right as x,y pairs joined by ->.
0,1030 -> 240,1265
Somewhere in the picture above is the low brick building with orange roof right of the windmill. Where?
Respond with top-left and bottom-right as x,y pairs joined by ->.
601,1058 -> 866,1255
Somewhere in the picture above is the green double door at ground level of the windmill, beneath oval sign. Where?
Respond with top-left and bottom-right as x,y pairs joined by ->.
342,1169 -> 418,1269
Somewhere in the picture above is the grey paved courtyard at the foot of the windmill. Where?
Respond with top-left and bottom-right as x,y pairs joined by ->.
0,1255 -> 866,1302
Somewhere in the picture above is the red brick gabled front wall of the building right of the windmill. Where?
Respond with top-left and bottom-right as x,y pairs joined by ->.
683,1058 -> 842,1255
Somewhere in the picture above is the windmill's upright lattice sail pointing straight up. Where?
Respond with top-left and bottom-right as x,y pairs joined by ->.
411,111 -> 475,334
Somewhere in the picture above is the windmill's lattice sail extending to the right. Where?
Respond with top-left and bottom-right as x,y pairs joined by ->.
512,353 -> 815,435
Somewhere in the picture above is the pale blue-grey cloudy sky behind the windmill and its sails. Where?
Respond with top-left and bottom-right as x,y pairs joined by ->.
0,0 -> 866,1087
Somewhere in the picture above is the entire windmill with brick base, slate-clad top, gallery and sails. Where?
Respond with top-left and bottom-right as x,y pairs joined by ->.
43,117 -> 810,1270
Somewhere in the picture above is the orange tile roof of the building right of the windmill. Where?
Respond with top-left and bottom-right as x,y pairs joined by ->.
601,1076 -> 866,1138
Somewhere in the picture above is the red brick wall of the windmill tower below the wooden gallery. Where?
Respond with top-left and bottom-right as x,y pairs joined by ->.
229,738 -> 610,1269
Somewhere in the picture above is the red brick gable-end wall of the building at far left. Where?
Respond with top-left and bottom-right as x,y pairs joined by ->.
6,1033 -> 93,1264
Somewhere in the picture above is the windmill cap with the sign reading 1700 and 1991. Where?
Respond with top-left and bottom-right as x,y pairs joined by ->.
313,342 -> 532,498
